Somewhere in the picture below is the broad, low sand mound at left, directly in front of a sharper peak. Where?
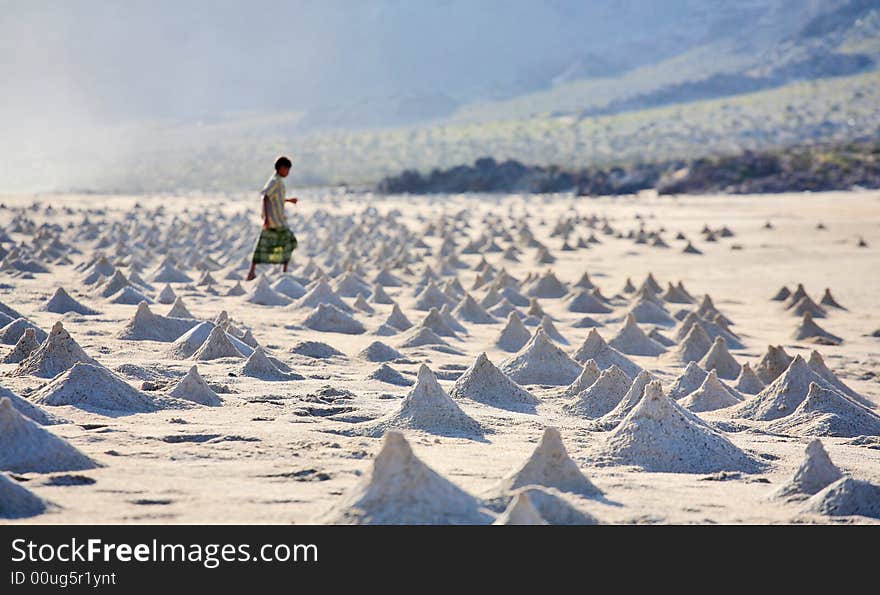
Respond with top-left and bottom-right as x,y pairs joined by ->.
31,363 -> 160,413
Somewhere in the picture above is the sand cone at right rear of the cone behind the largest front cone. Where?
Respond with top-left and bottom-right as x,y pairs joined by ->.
449,353 -> 539,412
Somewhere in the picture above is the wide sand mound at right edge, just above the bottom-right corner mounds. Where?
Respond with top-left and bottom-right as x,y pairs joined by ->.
767,382 -> 880,438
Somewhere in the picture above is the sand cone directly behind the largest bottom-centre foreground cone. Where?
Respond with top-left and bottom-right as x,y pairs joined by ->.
355,364 -> 483,438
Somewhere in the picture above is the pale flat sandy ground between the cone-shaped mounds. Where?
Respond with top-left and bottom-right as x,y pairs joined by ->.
0,192 -> 880,524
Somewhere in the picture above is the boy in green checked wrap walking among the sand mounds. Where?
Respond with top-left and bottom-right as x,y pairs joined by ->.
247,157 -> 297,281
